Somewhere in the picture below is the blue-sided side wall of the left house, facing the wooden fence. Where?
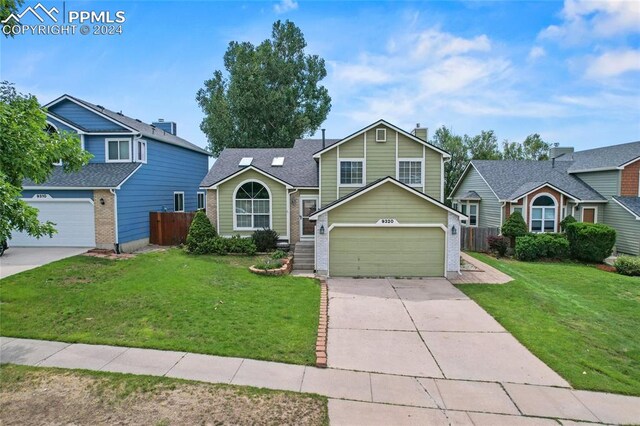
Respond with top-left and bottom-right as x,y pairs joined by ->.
116,138 -> 209,243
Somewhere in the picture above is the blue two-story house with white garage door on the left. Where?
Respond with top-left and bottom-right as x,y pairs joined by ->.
10,95 -> 210,252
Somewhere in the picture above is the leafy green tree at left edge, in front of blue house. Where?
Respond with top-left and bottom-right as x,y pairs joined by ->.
0,81 -> 91,240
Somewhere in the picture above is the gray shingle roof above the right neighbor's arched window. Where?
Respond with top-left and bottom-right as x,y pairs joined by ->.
471,160 -> 605,200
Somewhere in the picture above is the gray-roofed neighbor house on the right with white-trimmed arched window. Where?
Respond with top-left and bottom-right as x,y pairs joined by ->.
451,142 -> 640,256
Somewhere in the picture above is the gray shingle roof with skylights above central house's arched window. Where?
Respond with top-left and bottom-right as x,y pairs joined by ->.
200,139 -> 339,187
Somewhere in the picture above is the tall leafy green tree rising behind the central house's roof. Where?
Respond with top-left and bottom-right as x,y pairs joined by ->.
196,21 -> 331,154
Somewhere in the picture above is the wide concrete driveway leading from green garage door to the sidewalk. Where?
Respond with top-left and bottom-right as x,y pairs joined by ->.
327,278 -> 569,387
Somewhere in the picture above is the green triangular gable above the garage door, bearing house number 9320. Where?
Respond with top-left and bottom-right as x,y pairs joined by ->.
329,182 -> 448,225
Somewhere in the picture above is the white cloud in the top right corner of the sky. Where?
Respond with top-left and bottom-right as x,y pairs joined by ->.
539,0 -> 640,44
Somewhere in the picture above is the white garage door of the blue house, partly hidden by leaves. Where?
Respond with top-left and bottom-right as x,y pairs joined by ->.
9,198 -> 96,247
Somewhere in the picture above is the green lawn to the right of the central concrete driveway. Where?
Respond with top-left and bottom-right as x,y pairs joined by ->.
457,253 -> 640,395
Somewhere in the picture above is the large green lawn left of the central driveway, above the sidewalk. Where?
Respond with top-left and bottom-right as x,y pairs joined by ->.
0,249 -> 320,365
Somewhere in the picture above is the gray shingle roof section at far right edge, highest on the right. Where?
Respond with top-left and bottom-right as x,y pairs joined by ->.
563,141 -> 640,173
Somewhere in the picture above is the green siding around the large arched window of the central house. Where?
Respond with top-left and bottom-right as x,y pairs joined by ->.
218,170 -> 289,237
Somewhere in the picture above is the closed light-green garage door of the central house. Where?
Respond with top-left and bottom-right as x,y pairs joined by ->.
329,227 -> 445,277
